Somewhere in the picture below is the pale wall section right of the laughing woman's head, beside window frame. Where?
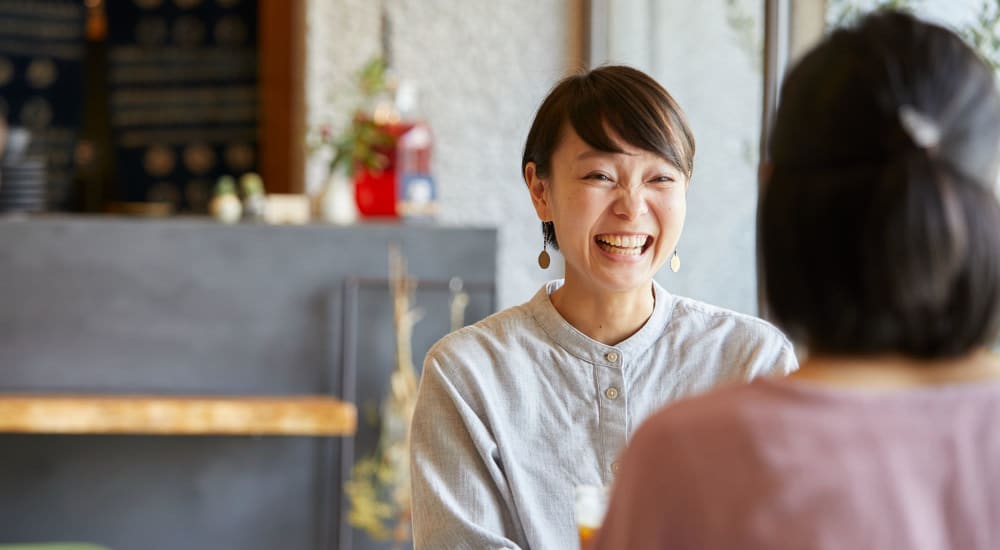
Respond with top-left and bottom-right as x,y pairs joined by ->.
601,0 -> 764,313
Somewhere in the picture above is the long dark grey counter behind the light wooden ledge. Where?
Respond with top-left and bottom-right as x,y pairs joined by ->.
0,217 -> 497,550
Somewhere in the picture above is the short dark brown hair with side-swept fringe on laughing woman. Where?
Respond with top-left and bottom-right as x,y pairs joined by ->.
521,65 -> 694,249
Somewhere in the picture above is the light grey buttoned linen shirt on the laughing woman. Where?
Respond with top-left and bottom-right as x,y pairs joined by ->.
410,281 -> 797,550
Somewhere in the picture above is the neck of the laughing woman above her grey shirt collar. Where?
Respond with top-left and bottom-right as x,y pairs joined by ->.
549,281 -> 655,346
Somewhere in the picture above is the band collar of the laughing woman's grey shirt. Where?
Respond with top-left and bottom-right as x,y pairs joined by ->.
527,279 -> 674,368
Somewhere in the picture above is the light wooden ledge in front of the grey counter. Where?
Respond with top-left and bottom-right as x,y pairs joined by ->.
0,394 -> 357,436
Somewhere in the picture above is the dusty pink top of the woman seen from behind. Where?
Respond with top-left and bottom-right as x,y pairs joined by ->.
593,379 -> 1000,550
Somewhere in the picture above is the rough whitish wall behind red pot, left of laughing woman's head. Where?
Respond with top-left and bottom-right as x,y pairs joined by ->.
306,0 -> 581,307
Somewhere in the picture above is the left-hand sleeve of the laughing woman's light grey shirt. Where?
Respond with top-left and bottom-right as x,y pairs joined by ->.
410,354 -> 522,550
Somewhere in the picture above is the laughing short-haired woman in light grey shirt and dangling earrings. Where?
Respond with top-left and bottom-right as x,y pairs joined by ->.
411,66 -> 795,549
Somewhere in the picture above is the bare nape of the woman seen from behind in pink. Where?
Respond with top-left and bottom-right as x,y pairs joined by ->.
790,350 -> 1000,388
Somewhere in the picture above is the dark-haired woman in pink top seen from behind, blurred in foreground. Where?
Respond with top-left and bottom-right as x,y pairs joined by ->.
596,12 -> 1000,550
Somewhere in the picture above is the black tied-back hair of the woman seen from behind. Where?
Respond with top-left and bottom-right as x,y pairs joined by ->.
758,11 -> 1000,359
